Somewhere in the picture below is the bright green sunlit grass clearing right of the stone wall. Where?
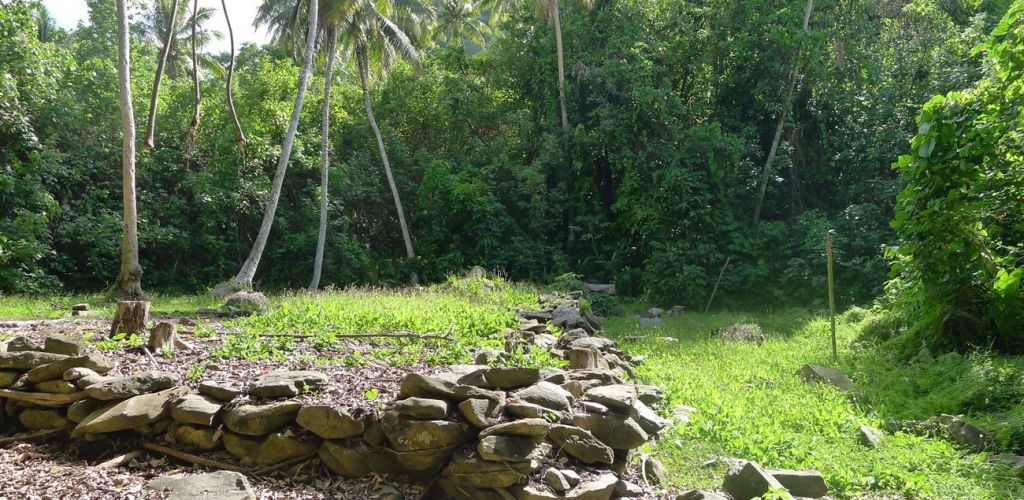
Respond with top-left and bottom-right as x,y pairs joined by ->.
606,310 -> 1024,498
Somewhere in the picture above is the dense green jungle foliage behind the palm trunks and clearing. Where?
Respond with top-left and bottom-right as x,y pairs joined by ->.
0,0 -> 1024,350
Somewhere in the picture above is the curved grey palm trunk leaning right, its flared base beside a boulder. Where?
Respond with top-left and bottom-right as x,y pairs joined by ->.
231,0 -> 318,287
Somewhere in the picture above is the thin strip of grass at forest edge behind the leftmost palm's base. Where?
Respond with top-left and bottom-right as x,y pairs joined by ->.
0,294 -> 224,320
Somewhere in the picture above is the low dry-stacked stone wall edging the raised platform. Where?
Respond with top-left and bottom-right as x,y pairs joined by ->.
0,294 -> 669,499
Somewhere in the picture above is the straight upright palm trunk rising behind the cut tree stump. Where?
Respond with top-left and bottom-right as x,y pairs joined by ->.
111,0 -> 143,299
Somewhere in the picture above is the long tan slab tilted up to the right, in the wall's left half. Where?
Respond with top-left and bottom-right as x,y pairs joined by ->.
72,387 -> 188,438
